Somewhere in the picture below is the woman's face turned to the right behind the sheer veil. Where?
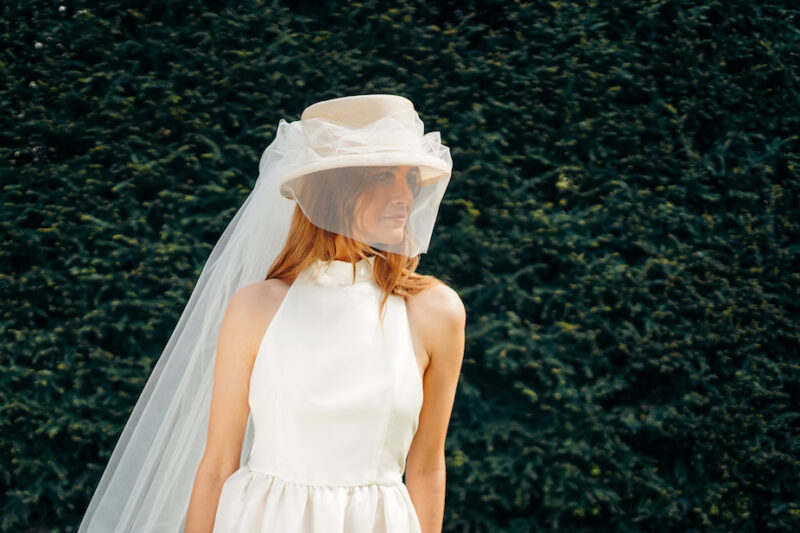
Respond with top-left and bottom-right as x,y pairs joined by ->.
355,166 -> 421,244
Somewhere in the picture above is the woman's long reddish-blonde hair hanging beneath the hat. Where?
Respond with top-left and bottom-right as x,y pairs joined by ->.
266,167 -> 442,324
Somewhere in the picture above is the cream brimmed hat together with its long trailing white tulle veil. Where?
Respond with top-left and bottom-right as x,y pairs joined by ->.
78,94 -> 452,533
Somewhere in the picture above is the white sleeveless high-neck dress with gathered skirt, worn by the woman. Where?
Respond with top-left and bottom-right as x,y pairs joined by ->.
213,257 -> 423,533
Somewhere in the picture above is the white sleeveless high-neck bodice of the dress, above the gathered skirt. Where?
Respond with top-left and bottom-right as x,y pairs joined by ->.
248,257 -> 422,485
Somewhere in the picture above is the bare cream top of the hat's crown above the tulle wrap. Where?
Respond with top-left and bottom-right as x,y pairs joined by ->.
300,94 -> 417,130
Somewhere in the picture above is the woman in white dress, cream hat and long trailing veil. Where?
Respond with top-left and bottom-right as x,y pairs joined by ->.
76,95 -> 465,533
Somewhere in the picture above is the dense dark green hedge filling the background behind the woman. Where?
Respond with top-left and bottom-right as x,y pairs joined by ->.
0,0 -> 800,532
